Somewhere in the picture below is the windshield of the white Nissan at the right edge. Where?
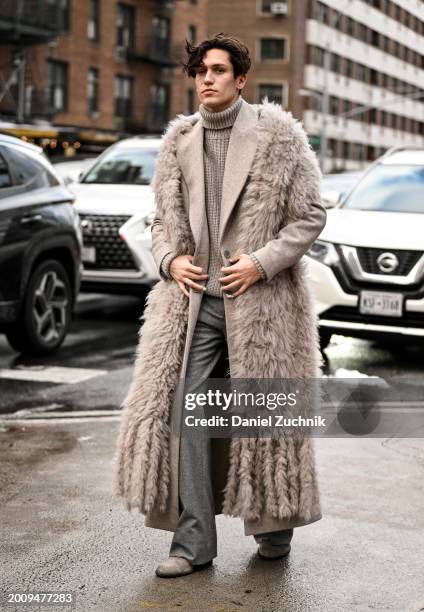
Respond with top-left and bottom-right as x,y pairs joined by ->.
343,164 -> 424,213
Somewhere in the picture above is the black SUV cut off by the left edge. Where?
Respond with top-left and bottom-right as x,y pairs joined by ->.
0,134 -> 82,355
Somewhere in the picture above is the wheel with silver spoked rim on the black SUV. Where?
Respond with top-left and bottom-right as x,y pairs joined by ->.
6,259 -> 72,355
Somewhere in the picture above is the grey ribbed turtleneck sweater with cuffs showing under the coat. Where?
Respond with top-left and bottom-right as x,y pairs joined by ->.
161,96 -> 265,298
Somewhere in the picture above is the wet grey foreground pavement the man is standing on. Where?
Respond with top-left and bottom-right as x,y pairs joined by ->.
0,414 -> 424,612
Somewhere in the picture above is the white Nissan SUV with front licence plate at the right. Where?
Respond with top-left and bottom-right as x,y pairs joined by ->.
307,148 -> 424,347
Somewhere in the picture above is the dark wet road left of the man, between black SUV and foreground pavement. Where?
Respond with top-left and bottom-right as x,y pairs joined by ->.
0,294 -> 143,414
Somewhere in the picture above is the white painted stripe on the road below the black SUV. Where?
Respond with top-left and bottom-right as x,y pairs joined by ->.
0,366 -> 108,385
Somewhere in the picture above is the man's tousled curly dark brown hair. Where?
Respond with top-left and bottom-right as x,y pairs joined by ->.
182,32 -> 251,79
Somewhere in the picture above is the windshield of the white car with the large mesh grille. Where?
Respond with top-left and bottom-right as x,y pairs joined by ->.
81,148 -> 158,185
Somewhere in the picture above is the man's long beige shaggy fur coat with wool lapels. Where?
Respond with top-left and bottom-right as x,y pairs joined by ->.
116,101 -> 325,533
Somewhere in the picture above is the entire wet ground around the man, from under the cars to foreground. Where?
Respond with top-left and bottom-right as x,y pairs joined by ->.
0,295 -> 424,612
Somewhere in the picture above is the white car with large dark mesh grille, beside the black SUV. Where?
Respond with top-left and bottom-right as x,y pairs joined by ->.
70,137 -> 161,295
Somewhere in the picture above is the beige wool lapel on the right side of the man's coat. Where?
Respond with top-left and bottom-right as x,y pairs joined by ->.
219,100 -> 258,242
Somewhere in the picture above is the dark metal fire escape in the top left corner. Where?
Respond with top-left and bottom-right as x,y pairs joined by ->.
0,0 -> 60,123
